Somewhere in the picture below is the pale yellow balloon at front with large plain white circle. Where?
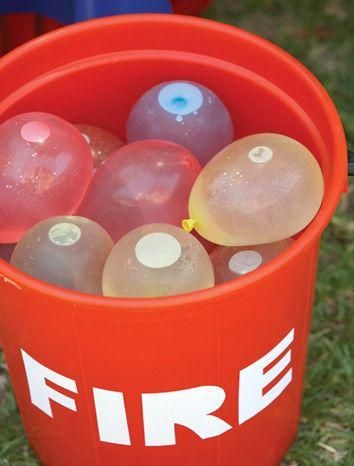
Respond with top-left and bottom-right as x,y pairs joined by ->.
103,224 -> 214,298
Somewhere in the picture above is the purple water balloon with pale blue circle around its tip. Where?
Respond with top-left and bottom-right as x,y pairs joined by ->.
127,81 -> 234,165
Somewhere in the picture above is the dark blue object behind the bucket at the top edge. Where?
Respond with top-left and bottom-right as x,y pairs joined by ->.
0,0 -> 172,24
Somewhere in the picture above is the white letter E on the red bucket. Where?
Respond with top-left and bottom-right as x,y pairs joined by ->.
238,329 -> 294,424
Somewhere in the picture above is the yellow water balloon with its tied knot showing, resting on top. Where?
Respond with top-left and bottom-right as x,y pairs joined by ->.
189,133 -> 324,246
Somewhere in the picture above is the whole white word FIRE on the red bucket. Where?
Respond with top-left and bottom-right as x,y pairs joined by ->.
21,329 -> 295,446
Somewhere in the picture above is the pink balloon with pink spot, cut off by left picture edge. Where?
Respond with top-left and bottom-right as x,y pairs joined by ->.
0,112 -> 93,243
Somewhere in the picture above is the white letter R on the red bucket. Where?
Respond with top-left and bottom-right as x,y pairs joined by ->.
142,386 -> 232,446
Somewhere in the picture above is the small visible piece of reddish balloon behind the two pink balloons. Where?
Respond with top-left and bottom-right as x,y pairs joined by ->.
75,124 -> 124,168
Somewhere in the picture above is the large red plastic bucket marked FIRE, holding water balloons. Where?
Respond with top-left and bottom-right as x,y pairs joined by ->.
0,15 -> 347,466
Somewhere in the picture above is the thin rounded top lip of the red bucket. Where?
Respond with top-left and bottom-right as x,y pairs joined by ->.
0,15 -> 346,312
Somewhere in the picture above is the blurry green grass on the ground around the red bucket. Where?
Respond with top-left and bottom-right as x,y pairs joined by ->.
0,0 -> 354,466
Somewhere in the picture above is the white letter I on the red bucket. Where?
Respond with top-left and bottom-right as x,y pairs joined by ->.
93,388 -> 131,445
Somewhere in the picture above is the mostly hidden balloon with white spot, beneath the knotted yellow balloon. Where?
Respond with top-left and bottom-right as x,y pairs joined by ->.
210,238 -> 294,284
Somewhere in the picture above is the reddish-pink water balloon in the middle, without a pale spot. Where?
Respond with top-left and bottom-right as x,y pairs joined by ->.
79,140 -> 201,241
